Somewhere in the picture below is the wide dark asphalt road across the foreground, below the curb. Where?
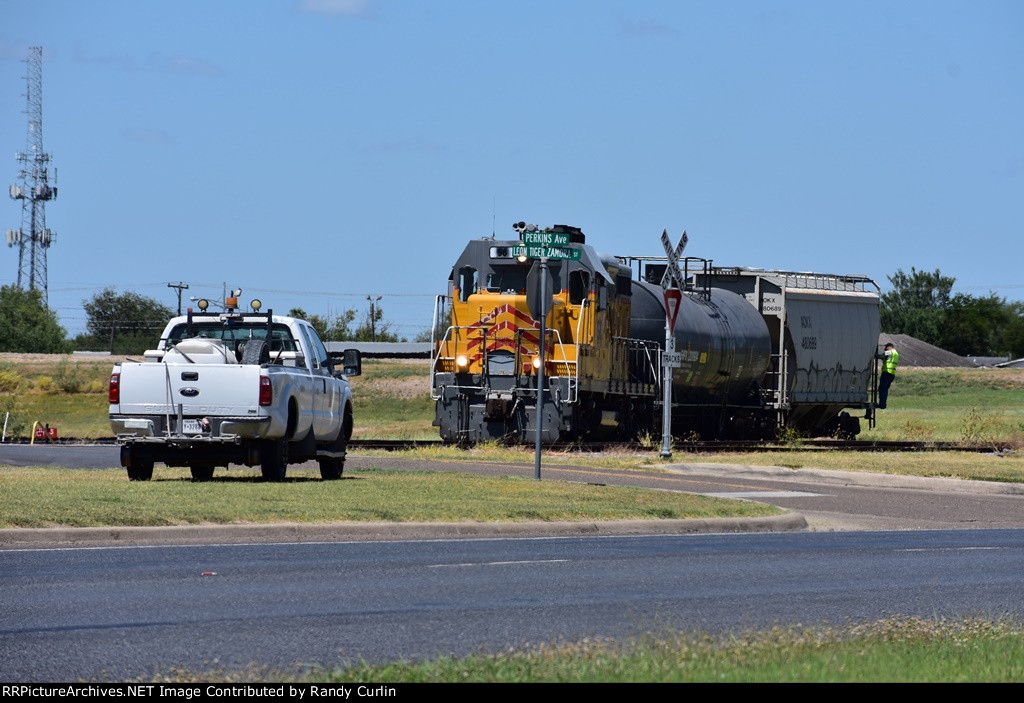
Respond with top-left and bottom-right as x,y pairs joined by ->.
0,530 -> 1024,682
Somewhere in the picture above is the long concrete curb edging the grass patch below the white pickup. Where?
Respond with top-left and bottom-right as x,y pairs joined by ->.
0,513 -> 808,550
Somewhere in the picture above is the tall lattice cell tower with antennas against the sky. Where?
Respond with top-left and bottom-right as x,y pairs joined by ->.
7,46 -> 57,303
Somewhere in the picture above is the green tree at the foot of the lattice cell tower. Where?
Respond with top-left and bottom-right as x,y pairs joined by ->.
0,285 -> 68,354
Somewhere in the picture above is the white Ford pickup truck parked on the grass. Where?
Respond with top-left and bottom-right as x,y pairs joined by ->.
110,299 -> 360,481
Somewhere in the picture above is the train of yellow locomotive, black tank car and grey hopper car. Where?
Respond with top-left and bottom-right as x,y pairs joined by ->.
431,223 -> 879,443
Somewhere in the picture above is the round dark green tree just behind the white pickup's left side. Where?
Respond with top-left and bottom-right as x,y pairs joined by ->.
76,288 -> 174,354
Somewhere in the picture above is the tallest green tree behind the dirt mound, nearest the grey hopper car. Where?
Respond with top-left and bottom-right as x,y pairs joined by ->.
880,267 -> 956,345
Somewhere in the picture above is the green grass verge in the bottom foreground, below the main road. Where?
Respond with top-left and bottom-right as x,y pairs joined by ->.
142,617 -> 1024,685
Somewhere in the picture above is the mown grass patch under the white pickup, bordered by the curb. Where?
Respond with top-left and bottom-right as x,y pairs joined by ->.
0,467 -> 782,527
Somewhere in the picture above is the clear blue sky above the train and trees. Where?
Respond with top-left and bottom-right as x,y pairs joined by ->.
0,0 -> 1024,337
